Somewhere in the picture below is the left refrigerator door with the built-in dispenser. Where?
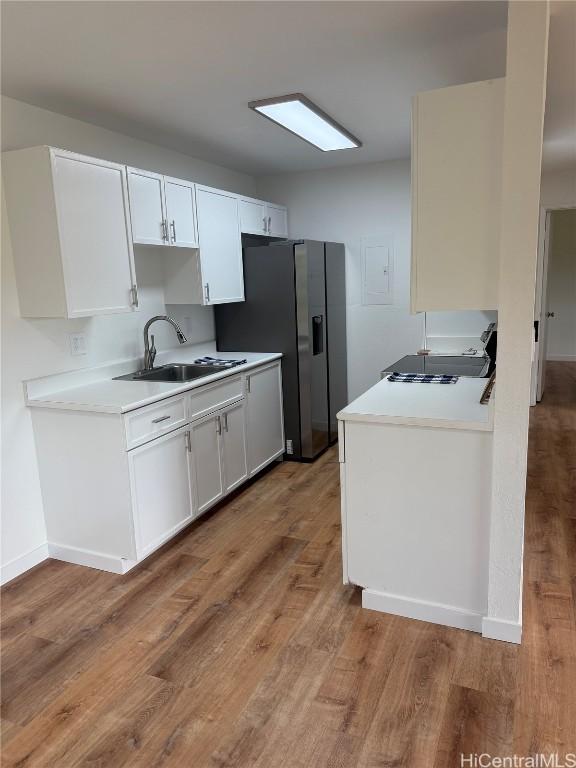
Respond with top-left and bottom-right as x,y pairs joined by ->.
294,241 -> 330,459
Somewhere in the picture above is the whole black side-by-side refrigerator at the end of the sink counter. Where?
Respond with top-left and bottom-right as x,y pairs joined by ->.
214,240 -> 348,461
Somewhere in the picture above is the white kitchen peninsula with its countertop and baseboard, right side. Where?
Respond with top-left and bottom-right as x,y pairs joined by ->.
338,377 -> 492,632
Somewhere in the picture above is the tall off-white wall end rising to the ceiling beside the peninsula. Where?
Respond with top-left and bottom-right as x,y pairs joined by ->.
482,2 -> 549,642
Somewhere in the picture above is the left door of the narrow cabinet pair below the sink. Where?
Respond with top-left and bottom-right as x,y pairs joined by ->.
189,413 -> 224,515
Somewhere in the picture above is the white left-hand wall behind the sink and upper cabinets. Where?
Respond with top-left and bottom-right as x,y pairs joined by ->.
2,98 -> 254,576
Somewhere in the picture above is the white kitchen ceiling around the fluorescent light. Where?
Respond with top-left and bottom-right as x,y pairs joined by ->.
2,0 -> 574,175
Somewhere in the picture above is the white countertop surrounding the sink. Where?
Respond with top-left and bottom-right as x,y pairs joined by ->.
24,344 -> 282,413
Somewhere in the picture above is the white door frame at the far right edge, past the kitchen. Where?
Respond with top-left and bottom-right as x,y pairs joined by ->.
530,204 -> 576,405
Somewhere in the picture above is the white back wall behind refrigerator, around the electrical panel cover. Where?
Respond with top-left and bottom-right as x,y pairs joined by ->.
256,160 -> 424,399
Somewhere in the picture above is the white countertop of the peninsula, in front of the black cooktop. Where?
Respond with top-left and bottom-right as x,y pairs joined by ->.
338,377 -> 493,431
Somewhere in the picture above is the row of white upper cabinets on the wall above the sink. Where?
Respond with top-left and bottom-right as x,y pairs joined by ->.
3,147 -> 288,318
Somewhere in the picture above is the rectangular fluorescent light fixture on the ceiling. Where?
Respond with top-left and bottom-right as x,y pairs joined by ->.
248,93 -> 362,152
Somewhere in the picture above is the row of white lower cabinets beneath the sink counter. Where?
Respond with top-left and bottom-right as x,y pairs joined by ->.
32,361 -> 284,573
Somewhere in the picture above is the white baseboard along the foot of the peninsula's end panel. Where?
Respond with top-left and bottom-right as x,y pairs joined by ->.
362,589 -> 483,632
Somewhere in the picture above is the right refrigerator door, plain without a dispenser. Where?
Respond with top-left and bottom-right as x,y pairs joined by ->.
325,243 -> 348,444
